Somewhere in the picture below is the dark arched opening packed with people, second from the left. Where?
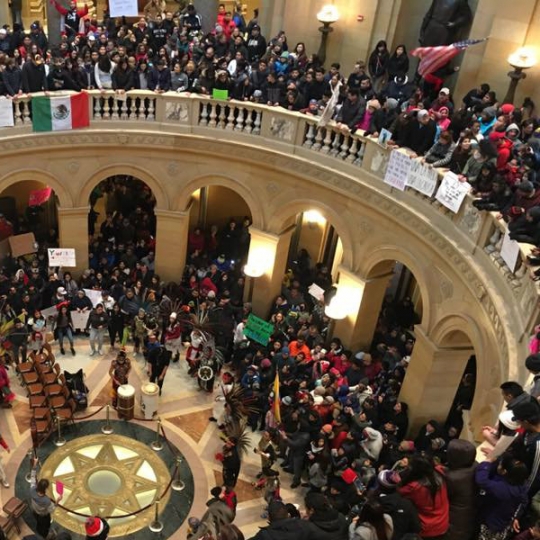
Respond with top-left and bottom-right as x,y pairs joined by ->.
88,175 -> 156,272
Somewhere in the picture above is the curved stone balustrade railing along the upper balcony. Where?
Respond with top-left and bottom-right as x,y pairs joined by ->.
5,90 -> 539,332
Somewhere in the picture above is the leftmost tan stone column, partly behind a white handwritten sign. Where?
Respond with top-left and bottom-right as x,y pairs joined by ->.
58,206 -> 90,276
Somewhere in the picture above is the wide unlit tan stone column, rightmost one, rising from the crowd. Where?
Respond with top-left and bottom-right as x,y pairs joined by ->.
399,326 -> 474,434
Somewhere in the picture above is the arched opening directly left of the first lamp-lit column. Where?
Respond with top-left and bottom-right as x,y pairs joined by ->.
186,184 -> 252,269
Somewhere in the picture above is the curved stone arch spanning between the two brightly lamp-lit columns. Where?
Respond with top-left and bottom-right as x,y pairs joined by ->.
268,193 -> 354,268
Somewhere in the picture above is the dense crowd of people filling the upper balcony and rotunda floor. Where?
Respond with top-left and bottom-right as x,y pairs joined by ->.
0,0 -> 540,540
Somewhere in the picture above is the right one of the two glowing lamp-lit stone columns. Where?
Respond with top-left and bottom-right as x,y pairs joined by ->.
332,267 -> 392,352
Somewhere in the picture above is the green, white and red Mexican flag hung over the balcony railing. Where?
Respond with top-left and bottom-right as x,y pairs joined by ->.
32,92 -> 90,131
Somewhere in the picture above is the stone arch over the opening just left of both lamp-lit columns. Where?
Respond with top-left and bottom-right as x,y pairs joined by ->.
173,173 -> 265,229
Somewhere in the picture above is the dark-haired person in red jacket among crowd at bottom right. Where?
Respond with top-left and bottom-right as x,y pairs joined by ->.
398,455 -> 450,540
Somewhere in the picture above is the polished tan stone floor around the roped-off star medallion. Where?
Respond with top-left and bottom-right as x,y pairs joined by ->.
0,338 -> 303,540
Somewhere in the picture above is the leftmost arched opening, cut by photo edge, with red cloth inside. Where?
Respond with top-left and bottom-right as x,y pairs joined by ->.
0,180 -> 58,248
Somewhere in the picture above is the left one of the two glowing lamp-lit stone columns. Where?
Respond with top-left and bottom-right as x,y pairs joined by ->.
246,226 -> 295,319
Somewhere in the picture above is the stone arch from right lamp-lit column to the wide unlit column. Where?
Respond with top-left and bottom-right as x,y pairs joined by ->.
360,243 -> 433,328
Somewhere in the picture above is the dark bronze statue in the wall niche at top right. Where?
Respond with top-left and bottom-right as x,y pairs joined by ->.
419,0 -> 472,47
